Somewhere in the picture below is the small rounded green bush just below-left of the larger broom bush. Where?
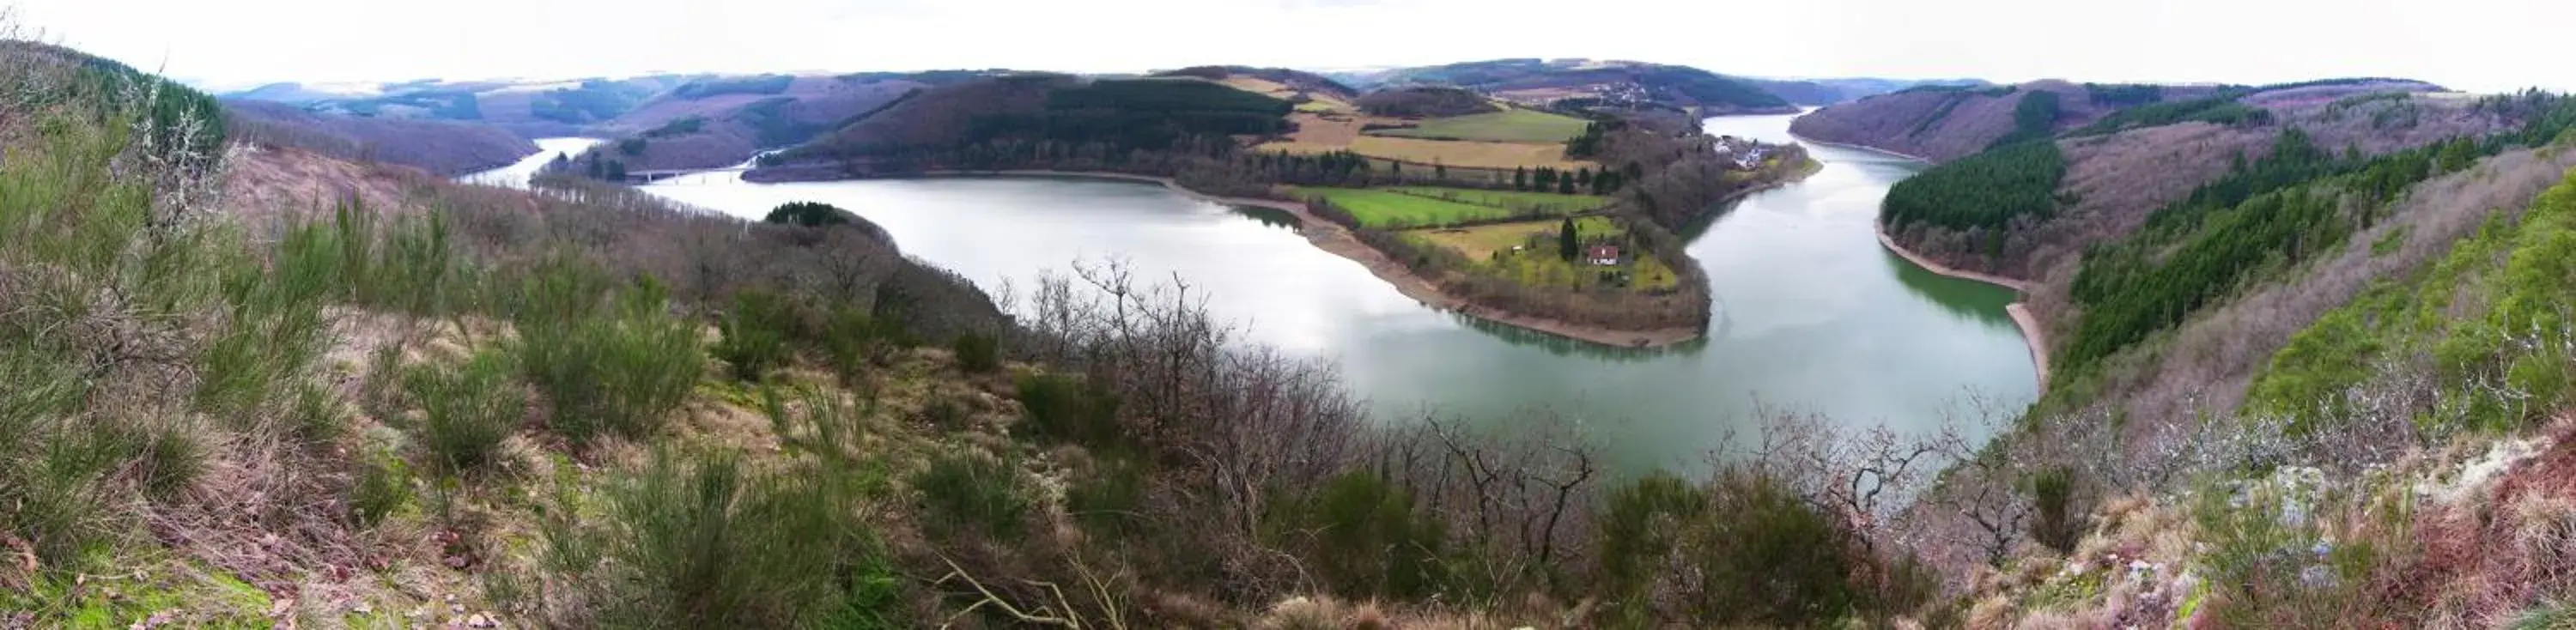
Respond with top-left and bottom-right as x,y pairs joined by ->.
402,352 -> 528,473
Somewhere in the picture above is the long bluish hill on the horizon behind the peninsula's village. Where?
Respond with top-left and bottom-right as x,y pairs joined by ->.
1329,59 -> 1798,113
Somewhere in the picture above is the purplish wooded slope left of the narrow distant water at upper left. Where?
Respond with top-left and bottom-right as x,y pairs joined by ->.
224,100 -> 536,175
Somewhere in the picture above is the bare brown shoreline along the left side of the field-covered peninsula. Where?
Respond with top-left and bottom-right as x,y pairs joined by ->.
904,170 -> 1710,349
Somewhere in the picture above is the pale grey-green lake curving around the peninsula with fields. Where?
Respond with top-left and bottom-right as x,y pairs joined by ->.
644,116 -> 2038,470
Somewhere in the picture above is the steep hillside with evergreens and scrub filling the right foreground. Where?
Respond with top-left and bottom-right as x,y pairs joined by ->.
1932,93 -> 2576,627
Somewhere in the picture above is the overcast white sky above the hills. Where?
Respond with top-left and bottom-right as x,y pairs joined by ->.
20,0 -> 2576,90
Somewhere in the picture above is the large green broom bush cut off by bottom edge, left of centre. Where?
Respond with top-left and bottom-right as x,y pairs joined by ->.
544,450 -> 902,627
